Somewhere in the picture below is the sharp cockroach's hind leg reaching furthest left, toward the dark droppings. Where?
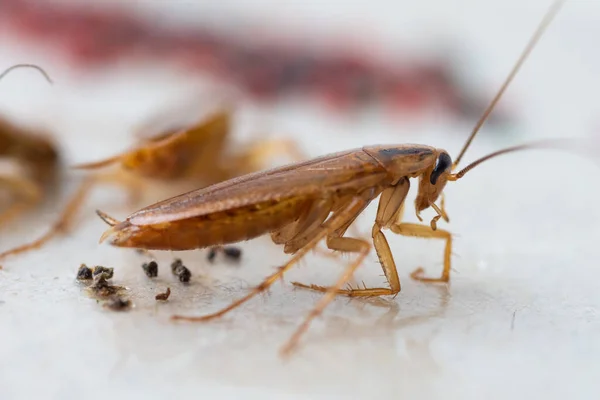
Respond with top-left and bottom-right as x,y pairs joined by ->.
171,197 -> 368,340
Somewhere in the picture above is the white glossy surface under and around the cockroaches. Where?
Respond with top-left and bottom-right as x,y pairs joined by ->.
0,0 -> 600,399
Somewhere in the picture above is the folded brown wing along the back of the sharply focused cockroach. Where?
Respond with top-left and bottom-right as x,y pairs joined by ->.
127,149 -> 388,225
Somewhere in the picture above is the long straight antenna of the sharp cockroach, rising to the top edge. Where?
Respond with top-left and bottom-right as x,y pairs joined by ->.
452,0 -> 566,170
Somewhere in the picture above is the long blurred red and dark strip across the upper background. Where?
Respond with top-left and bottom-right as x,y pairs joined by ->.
0,0 -> 508,123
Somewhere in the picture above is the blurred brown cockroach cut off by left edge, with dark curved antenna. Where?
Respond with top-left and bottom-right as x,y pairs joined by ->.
0,64 -> 60,230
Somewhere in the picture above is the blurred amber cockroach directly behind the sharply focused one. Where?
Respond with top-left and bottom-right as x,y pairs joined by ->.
0,107 -> 301,259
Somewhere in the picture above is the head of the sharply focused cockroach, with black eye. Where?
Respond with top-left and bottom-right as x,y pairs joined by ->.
415,150 -> 452,212
